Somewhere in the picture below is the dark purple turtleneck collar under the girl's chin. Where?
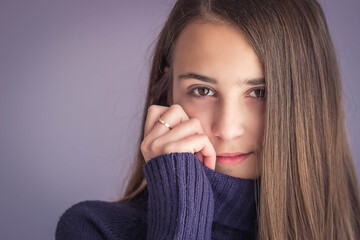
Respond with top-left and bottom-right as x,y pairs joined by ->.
204,166 -> 257,232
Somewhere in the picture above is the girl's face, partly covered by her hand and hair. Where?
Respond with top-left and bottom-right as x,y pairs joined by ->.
170,21 -> 265,179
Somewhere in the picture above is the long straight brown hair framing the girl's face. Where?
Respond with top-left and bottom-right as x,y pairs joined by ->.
122,0 -> 360,240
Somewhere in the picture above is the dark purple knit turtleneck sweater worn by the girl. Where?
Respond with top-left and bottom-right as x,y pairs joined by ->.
56,153 -> 257,240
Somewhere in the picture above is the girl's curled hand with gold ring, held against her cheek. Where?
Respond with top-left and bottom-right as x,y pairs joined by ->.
141,104 -> 216,170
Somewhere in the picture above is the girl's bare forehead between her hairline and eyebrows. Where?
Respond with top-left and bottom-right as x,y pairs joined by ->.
173,21 -> 263,81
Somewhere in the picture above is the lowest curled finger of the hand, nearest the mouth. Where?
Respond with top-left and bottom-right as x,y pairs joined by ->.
163,134 -> 216,170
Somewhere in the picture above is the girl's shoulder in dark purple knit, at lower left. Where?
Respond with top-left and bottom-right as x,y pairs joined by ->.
56,201 -> 147,239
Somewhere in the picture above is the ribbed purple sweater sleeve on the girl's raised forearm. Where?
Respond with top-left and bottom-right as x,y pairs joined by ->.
144,153 -> 214,239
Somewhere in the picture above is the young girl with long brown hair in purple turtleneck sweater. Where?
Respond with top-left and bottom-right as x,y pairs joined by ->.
56,0 -> 360,240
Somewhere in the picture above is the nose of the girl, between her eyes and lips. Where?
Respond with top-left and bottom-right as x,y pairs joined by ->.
212,103 -> 245,141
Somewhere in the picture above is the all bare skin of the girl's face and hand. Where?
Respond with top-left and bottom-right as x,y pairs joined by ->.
141,22 -> 265,179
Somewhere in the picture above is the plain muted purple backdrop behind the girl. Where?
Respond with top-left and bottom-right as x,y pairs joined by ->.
0,0 -> 360,239
